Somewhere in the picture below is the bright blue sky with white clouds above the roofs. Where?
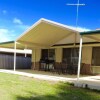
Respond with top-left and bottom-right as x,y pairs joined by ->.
0,0 -> 100,42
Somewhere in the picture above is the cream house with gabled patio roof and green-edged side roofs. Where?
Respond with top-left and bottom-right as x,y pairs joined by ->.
0,18 -> 100,74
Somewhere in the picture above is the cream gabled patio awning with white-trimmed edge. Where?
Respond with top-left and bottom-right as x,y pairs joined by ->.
16,18 -> 79,48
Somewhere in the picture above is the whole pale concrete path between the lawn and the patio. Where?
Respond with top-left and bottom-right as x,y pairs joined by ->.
0,69 -> 100,90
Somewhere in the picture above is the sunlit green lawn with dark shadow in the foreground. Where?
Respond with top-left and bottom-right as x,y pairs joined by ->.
0,73 -> 100,100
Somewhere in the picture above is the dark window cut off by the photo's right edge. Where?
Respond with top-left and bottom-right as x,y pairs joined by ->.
92,47 -> 100,66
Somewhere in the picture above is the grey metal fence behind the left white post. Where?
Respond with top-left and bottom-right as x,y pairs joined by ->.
0,53 -> 31,69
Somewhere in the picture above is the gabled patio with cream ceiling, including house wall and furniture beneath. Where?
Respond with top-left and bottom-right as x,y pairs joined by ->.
14,18 -> 80,74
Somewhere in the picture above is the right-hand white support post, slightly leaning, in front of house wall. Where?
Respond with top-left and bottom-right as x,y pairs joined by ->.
77,37 -> 82,81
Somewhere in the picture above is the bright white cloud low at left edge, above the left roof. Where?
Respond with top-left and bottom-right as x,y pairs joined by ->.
0,28 -> 16,42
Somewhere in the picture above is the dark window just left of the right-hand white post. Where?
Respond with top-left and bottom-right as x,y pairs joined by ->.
62,48 -> 79,65
